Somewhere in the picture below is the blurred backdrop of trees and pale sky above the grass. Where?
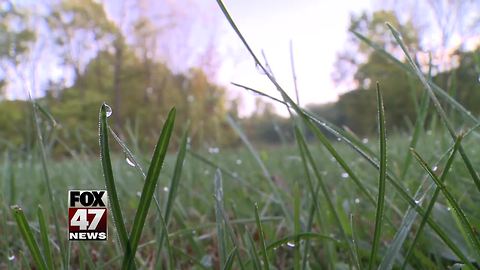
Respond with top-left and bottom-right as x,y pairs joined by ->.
0,0 -> 480,158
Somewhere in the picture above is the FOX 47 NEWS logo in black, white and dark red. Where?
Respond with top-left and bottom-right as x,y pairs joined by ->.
68,190 -> 108,240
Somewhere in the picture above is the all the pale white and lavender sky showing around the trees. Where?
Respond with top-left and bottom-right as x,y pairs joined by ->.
9,0 -> 372,115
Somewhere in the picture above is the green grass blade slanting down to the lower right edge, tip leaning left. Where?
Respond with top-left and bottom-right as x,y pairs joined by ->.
412,149 -> 480,258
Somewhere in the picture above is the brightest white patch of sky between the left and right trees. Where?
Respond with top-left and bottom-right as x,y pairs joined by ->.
213,0 -> 371,113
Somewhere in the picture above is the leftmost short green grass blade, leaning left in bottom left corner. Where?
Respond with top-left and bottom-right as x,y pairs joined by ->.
12,206 -> 48,270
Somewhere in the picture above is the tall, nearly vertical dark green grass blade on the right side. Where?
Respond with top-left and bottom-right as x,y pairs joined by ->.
368,82 -> 387,269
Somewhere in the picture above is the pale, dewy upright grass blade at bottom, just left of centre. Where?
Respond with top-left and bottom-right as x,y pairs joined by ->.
215,170 -> 227,268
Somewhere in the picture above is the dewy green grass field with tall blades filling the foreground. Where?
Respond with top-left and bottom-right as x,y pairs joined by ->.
0,3 -> 480,269
